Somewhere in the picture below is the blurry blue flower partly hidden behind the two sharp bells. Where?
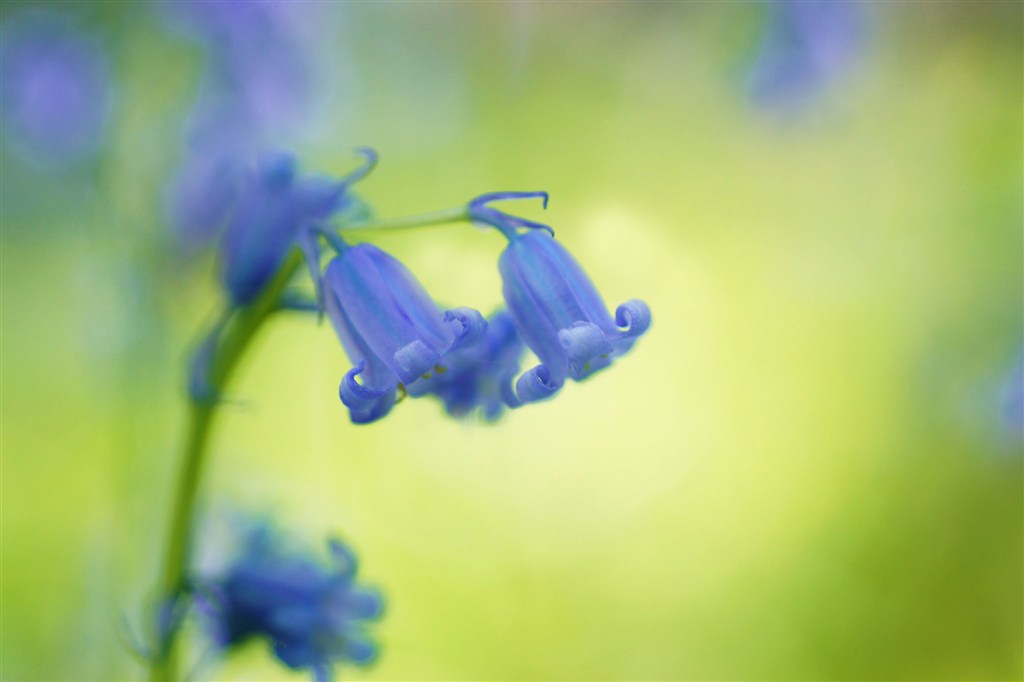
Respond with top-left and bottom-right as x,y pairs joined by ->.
407,310 -> 526,421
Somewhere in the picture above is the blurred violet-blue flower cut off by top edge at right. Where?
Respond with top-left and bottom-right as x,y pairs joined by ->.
750,0 -> 863,106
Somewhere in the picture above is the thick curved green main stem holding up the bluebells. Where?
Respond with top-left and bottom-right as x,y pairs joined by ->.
150,251 -> 302,681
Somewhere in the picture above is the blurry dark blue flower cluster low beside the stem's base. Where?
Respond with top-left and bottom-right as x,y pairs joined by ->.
196,525 -> 384,680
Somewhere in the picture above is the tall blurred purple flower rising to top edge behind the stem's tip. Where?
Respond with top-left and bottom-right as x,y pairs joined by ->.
160,0 -> 312,247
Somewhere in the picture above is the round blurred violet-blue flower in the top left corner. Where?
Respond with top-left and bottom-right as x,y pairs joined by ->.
0,10 -> 113,170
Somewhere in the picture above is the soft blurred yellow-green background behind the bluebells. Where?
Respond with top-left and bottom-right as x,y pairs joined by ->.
0,2 -> 1024,680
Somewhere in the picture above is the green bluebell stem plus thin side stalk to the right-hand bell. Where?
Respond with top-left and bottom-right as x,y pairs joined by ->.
150,206 -> 469,681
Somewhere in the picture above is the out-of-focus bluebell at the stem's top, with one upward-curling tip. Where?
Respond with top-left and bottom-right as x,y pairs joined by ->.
220,148 -> 377,305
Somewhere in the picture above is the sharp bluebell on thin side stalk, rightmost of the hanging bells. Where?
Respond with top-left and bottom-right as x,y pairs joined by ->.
469,193 -> 650,407
